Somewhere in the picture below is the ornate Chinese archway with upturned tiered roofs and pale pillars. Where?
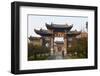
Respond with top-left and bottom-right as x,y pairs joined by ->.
34,24 -> 80,56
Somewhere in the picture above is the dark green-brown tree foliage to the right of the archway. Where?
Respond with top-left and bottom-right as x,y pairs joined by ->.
68,37 -> 88,58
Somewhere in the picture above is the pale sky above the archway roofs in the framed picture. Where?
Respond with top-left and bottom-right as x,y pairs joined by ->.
27,14 -> 88,37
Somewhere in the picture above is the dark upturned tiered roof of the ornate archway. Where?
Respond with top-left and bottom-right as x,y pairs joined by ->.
34,23 -> 81,36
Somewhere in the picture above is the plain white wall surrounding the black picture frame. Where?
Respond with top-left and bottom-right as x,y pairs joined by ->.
0,0 -> 100,76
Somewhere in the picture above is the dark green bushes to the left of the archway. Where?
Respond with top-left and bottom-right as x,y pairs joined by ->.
28,43 -> 50,60
